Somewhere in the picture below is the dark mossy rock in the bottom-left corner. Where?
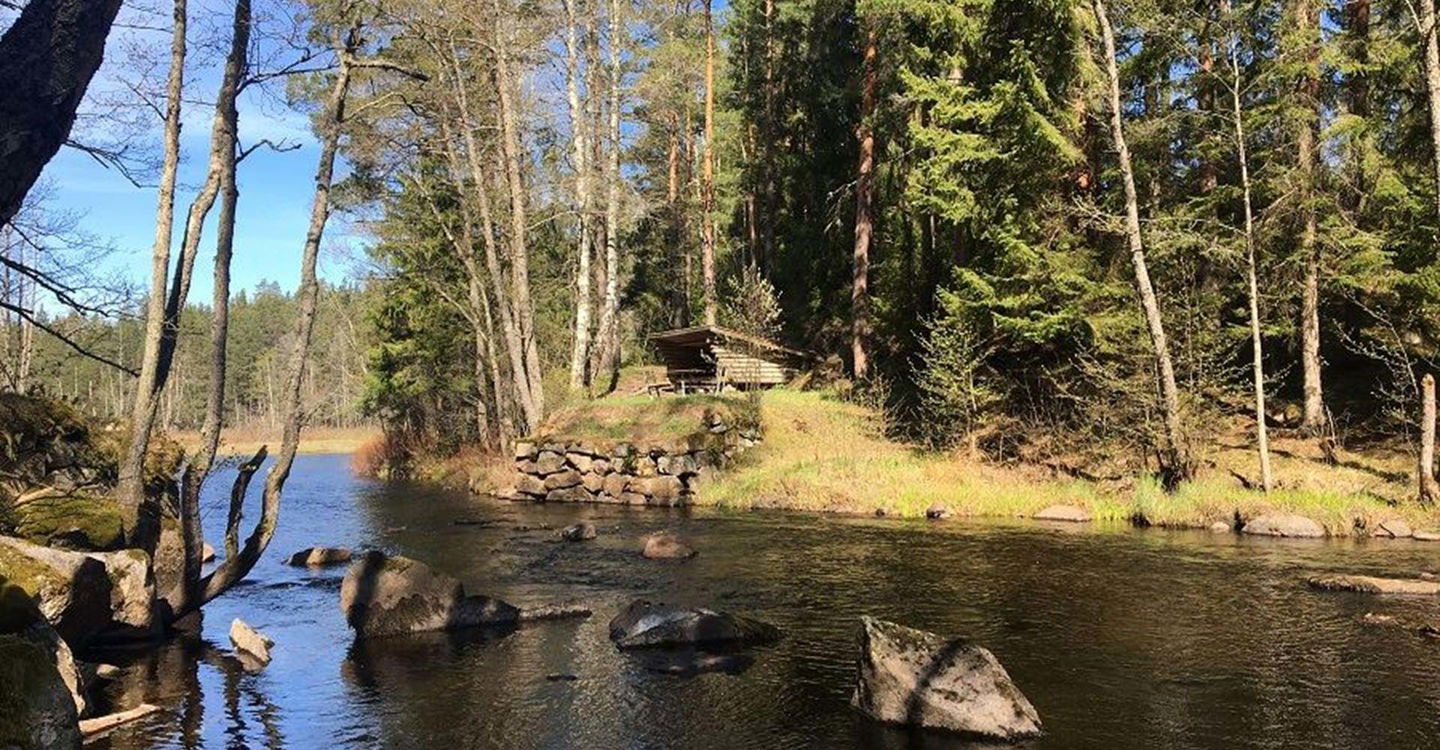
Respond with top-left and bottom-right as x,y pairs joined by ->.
0,635 -> 81,750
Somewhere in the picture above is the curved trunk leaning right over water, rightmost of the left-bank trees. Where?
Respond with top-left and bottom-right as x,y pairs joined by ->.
177,37 -> 359,615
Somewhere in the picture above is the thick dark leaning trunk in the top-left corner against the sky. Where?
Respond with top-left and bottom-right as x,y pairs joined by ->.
0,0 -> 120,226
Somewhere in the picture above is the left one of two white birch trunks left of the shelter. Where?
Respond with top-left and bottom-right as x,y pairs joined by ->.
564,0 -> 590,389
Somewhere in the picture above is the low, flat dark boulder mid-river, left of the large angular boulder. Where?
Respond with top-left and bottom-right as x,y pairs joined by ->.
611,599 -> 780,648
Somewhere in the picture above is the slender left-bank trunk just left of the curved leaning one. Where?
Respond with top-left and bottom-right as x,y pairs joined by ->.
170,0 -> 251,610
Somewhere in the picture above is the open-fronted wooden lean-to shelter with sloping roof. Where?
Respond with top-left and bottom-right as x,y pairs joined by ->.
648,325 -> 805,393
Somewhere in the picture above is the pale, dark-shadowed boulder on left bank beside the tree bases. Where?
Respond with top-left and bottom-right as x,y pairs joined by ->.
0,537 -> 158,648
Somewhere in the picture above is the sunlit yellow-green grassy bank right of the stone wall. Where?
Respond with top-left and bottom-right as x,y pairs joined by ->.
700,390 -> 1440,536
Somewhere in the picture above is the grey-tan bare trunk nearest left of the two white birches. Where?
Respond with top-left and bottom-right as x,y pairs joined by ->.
494,0 -> 544,433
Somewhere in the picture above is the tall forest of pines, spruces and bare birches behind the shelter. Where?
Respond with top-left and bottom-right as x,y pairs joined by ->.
4,0 -> 1440,487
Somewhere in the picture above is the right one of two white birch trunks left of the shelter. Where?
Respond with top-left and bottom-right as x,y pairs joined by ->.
593,0 -> 624,393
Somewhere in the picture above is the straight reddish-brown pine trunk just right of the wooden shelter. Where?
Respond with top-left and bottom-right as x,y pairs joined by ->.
850,22 -> 876,380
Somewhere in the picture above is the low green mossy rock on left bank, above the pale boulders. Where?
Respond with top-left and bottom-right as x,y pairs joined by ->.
0,492 -> 125,551
